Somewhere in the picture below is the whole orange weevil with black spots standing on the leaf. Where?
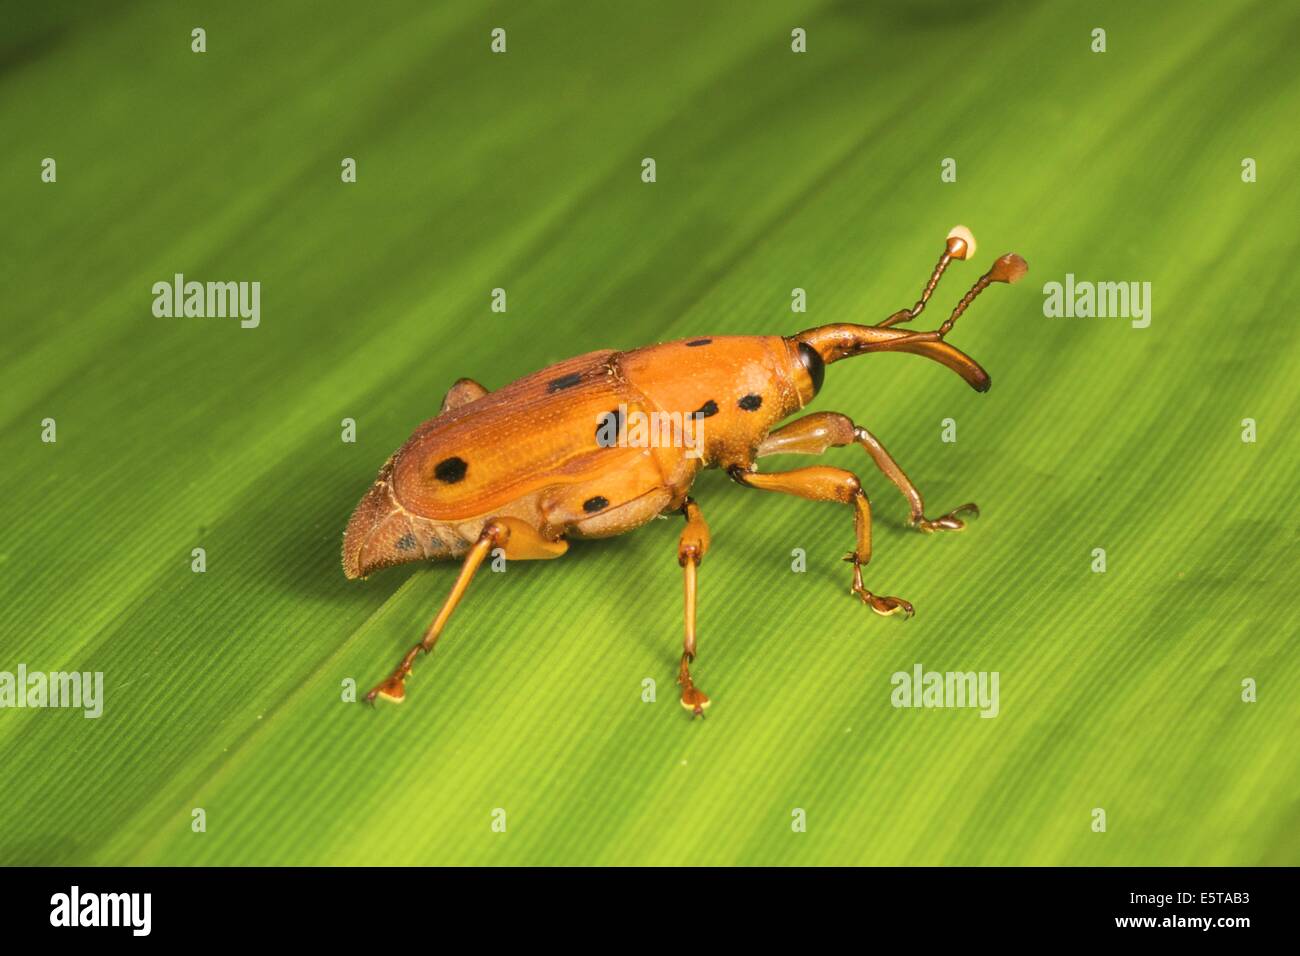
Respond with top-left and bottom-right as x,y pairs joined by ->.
343,226 -> 1028,717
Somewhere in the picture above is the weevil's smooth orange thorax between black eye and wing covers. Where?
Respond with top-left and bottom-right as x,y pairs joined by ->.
619,336 -> 814,468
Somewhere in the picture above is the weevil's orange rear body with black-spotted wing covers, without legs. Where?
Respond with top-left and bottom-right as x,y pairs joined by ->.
343,351 -> 694,578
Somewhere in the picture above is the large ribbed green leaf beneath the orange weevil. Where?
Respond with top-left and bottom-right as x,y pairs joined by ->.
0,3 -> 1300,865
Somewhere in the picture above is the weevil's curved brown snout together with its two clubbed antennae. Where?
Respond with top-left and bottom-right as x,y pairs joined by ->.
790,226 -> 1030,392
